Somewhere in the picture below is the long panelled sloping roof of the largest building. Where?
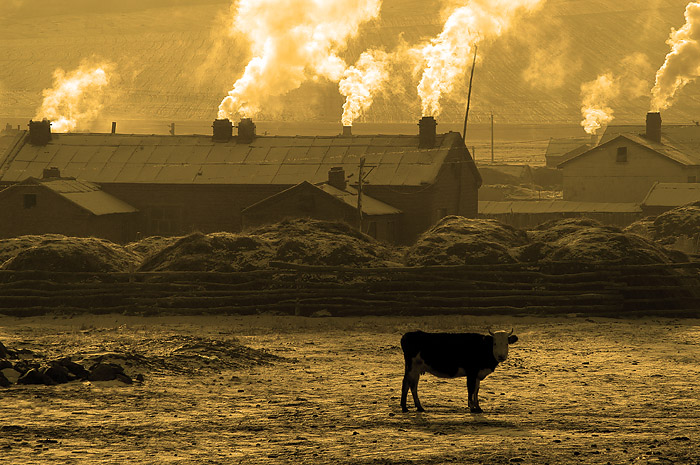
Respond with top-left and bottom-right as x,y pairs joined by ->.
0,132 -> 480,186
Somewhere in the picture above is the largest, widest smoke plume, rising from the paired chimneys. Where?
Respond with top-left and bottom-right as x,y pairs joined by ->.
218,0 -> 381,119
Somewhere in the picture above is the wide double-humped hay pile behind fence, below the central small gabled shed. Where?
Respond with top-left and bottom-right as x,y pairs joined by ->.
141,219 -> 398,271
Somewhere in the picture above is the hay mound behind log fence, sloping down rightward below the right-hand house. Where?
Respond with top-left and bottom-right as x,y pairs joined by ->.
529,219 -> 675,264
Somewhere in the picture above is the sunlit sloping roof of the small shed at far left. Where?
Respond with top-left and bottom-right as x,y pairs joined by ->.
15,178 -> 138,216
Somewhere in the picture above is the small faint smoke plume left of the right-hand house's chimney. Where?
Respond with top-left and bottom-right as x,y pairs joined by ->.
581,73 -> 620,134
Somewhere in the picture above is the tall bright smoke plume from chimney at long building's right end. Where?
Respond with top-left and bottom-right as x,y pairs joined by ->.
414,0 -> 543,116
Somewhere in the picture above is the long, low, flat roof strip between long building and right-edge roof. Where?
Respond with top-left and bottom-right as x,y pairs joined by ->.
479,200 -> 642,215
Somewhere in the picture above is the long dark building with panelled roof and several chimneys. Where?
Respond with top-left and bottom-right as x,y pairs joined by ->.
0,117 -> 481,243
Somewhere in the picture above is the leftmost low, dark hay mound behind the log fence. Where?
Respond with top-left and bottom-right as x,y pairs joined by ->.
2,235 -> 140,272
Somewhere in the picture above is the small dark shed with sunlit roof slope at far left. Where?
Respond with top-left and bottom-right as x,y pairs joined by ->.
0,168 -> 139,242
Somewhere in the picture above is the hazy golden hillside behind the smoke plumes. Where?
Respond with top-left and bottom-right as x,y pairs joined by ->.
0,0 -> 700,124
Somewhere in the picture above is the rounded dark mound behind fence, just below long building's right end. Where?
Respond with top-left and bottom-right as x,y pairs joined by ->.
405,216 -> 528,266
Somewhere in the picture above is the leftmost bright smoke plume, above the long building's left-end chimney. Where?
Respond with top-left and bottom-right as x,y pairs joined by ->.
34,62 -> 113,132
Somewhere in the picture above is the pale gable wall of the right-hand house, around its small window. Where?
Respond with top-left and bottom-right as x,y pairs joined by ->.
562,139 -> 700,203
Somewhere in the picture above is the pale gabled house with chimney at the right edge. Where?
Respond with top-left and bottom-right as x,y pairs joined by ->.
558,113 -> 700,203
